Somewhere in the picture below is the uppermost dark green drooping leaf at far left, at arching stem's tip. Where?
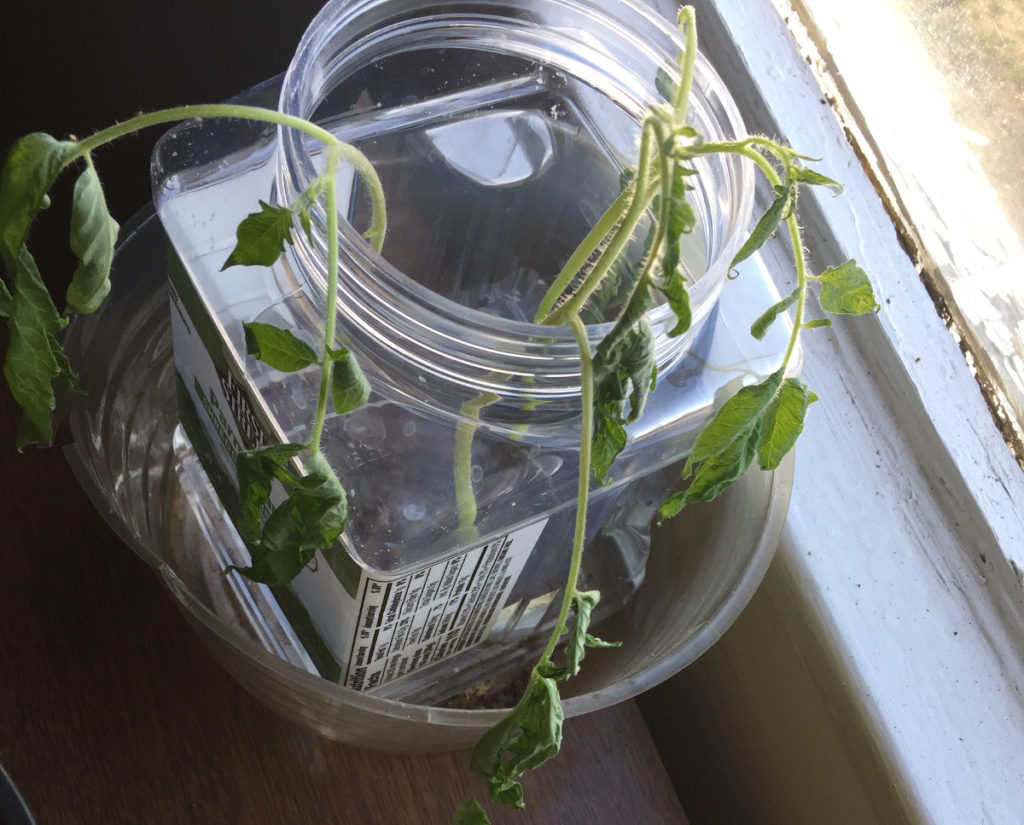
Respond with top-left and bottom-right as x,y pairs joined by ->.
0,132 -> 75,274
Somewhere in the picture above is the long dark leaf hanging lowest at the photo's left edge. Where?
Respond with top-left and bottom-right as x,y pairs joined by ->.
3,245 -> 76,449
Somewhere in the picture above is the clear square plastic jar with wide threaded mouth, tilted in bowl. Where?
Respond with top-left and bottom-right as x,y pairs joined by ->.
154,0 -> 753,703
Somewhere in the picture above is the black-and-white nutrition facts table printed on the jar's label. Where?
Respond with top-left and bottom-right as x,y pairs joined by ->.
343,521 -> 547,691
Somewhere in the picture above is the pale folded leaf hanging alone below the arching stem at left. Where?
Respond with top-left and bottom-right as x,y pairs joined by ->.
67,158 -> 119,313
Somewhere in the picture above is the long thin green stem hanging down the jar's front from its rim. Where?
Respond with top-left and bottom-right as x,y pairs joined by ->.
534,315 -> 594,672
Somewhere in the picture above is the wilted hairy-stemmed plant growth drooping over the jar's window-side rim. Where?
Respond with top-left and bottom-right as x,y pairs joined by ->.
466,7 -> 878,822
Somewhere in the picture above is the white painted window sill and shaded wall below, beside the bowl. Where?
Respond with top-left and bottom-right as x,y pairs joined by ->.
646,0 -> 1024,825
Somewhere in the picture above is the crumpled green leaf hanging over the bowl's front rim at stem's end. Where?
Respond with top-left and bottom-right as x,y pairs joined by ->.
469,670 -> 564,808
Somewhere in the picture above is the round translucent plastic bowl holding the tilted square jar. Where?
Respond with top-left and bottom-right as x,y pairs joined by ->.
66,204 -> 793,751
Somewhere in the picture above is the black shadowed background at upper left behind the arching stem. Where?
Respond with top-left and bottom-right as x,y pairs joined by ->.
0,0 -> 322,290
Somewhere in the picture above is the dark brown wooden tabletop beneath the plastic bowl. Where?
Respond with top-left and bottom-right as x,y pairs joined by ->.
0,389 -> 685,825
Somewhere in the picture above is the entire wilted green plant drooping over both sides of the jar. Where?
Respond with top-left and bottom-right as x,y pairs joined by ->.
0,7 -> 878,825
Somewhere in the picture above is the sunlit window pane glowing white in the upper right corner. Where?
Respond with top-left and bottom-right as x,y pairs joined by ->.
782,0 -> 1024,460
